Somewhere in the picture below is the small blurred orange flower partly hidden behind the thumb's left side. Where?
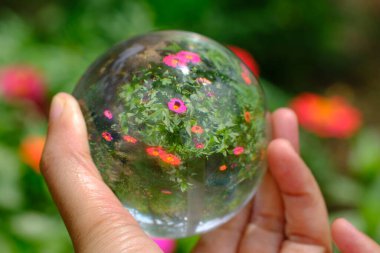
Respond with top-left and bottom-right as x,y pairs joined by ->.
20,136 -> 45,172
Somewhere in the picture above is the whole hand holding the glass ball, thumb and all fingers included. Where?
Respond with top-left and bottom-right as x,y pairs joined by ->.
41,93 -> 380,253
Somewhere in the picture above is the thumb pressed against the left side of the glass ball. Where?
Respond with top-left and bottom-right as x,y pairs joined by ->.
41,93 -> 161,252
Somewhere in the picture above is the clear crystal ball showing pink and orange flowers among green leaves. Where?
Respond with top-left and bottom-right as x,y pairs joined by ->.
73,31 -> 267,238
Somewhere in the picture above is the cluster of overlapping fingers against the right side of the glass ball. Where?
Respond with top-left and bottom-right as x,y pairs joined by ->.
195,109 -> 332,253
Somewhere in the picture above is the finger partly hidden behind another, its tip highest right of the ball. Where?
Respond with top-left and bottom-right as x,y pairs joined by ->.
240,108 -> 299,253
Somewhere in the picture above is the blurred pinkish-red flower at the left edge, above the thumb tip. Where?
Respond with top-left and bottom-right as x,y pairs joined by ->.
0,66 -> 45,105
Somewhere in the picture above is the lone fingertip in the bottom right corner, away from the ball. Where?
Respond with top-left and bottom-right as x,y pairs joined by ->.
332,219 -> 380,253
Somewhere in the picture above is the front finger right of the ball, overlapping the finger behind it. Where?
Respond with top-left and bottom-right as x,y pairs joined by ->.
268,139 -> 331,252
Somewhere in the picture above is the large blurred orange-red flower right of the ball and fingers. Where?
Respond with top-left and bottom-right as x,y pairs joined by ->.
290,93 -> 362,138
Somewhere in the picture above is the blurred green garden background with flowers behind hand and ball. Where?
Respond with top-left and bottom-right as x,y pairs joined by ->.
0,0 -> 380,253
